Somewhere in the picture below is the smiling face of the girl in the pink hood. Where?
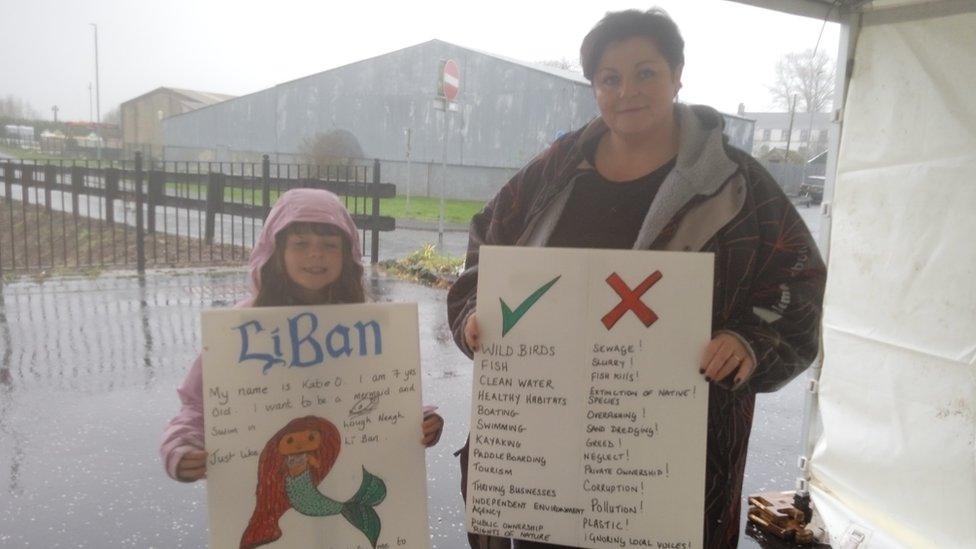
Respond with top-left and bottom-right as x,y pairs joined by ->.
282,232 -> 343,302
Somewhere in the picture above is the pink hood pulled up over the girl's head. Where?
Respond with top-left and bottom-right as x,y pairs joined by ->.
248,189 -> 363,297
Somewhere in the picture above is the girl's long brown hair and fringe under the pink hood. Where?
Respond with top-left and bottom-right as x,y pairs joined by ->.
254,222 -> 366,307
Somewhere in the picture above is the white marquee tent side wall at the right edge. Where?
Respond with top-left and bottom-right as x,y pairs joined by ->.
736,0 -> 976,548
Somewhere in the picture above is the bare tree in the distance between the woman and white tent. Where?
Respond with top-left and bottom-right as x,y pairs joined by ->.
768,50 -> 835,112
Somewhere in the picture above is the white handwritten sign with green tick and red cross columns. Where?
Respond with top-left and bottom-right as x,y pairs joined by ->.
466,246 -> 713,549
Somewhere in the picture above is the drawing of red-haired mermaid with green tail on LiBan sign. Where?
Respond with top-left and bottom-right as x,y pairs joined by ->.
240,416 -> 386,549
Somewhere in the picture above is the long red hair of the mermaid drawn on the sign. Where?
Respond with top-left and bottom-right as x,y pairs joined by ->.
240,416 -> 342,549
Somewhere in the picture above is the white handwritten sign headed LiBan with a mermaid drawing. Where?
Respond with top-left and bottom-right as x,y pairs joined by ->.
202,304 -> 429,549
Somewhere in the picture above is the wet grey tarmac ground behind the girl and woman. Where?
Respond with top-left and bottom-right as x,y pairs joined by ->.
0,203 -> 817,549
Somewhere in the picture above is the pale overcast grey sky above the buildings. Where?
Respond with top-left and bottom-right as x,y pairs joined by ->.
0,0 -> 838,120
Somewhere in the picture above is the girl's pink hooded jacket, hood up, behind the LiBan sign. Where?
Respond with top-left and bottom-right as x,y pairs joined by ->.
159,189 -> 362,480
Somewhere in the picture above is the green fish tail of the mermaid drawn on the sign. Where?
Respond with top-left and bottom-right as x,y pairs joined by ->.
285,467 -> 386,548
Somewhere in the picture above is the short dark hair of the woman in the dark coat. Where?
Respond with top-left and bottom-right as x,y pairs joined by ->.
580,8 -> 685,82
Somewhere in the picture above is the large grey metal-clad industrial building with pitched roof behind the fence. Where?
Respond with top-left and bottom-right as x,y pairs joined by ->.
163,40 -> 752,199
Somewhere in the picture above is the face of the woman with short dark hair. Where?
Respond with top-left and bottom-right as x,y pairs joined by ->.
593,36 -> 683,137
